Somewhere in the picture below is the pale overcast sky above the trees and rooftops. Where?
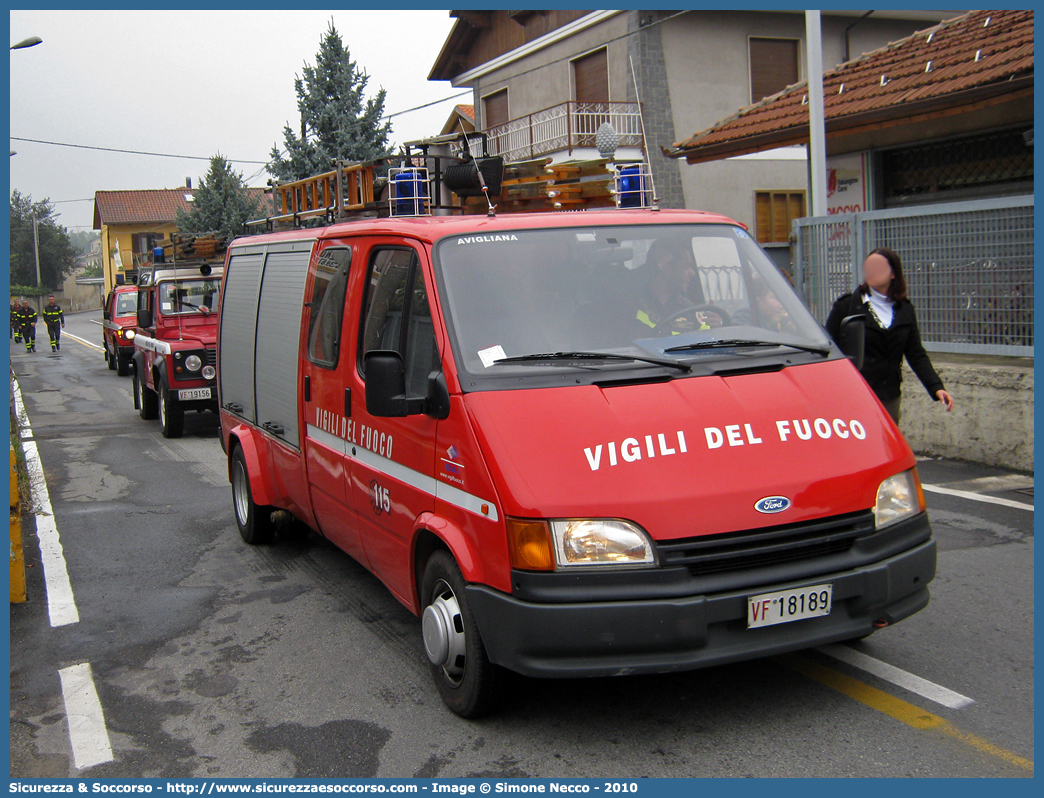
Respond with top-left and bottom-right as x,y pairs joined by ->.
9,10 -> 459,230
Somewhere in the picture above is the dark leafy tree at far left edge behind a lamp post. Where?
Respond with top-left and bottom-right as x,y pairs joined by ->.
10,189 -> 76,290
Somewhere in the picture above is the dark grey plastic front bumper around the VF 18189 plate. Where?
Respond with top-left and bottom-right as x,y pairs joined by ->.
467,519 -> 935,677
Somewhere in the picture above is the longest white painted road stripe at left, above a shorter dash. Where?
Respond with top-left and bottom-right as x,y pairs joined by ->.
11,376 -> 79,627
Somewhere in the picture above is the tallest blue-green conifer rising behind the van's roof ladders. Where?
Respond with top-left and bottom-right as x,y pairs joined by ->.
268,20 -> 392,181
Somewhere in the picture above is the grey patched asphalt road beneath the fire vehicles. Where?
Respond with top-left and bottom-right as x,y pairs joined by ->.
10,312 -> 1034,778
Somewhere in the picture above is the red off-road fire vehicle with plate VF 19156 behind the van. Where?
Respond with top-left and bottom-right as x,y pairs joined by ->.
132,256 -> 224,438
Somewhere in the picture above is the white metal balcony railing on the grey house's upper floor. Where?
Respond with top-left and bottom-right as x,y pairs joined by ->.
483,102 -> 642,161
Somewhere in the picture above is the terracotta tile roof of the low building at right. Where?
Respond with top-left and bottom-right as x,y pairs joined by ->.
664,10 -> 1034,162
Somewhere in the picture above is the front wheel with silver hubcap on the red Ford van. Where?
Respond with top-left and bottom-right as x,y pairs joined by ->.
421,549 -> 504,719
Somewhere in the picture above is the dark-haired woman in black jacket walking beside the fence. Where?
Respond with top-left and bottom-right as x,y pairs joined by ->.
827,247 -> 953,424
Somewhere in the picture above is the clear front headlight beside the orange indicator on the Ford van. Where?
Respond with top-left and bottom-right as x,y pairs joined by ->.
551,518 -> 656,567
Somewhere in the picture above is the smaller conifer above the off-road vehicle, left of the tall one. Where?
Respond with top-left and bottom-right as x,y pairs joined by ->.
175,154 -> 267,241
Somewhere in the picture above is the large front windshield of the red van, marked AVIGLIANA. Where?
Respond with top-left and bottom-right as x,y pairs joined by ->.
435,225 -> 830,376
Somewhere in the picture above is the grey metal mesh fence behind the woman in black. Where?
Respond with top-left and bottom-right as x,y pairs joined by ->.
793,195 -> 1034,357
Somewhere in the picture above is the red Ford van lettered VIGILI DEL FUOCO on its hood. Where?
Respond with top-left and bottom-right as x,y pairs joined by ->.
217,209 -> 935,717
